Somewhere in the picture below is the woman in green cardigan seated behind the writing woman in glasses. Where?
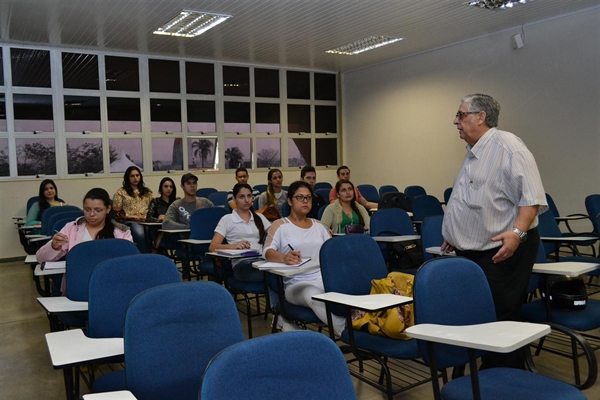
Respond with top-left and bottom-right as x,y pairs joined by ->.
321,179 -> 370,233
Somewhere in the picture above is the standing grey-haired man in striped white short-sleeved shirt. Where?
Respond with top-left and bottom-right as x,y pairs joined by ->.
442,94 -> 548,369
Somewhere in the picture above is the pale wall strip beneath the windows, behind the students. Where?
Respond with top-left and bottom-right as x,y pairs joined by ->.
0,168 -> 337,259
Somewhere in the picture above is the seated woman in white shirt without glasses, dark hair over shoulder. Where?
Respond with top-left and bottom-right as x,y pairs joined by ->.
209,183 -> 271,282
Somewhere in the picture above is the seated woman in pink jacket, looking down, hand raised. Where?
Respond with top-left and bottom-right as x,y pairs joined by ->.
36,188 -> 133,293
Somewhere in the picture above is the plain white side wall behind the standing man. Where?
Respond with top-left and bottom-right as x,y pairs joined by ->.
342,8 -> 600,214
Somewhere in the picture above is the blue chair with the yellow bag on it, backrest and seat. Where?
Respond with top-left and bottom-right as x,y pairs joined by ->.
319,234 -> 428,399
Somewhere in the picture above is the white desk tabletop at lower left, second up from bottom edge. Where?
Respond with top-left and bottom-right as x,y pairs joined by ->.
46,329 -> 124,368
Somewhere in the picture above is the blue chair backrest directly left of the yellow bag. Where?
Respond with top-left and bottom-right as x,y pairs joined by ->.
319,234 -> 388,315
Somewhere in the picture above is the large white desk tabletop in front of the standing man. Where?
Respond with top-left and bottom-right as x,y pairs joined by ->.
406,321 -> 550,353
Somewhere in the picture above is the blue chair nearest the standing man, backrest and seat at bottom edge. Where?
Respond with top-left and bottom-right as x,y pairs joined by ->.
409,257 -> 595,400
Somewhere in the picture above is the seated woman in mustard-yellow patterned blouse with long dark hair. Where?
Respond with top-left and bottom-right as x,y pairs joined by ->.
113,166 -> 152,253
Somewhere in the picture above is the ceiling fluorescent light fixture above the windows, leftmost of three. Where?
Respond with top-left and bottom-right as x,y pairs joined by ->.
154,10 -> 231,37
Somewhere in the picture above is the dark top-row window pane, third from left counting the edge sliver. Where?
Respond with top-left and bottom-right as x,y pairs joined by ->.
62,53 -> 100,89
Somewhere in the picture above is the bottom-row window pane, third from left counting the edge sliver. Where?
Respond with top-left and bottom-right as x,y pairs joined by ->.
67,138 -> 105,174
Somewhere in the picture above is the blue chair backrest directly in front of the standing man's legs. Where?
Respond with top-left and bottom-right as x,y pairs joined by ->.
413,257 -> 496,368
